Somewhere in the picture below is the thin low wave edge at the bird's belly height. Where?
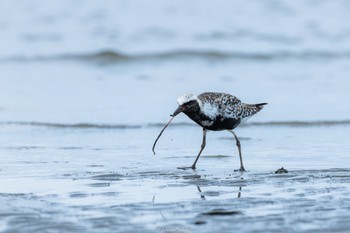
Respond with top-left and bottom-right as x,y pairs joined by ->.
0,120 -> 350,130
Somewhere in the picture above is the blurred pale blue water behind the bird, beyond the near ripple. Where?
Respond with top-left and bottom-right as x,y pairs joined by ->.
0,0 -> 350,124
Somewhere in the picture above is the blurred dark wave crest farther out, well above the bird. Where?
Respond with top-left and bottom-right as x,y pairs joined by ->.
0,50 -> 350,64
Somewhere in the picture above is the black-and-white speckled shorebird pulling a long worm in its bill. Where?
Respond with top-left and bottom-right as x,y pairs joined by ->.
152,92 -> 267,172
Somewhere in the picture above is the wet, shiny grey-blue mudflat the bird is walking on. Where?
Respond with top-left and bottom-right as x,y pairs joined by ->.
0,124 -> 350,232
